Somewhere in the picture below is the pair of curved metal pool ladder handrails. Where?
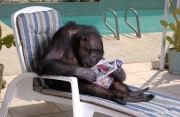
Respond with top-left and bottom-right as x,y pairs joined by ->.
104,8 -> 141,40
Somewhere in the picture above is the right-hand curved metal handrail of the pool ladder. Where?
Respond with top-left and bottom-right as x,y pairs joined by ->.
124,8 -> 141,38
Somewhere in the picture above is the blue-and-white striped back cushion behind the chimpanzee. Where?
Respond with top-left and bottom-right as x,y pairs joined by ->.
17,10 -> 62,88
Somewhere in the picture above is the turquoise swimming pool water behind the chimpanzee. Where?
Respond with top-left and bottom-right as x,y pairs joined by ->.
0,10 -> 174,35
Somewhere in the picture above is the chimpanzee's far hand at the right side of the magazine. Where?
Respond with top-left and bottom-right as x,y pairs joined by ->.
111,67 -> 126,82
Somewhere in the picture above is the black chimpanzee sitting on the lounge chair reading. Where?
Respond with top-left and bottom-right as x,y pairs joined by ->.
37,22 -> 154,104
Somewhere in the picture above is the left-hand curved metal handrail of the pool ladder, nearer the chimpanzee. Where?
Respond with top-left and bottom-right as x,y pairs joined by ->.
104,8 -> 120,40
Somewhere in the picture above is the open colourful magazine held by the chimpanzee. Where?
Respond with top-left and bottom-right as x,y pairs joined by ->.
91,59 -> 122,89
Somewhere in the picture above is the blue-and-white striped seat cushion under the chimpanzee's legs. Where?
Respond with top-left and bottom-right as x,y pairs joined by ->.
34,86 -> 180,117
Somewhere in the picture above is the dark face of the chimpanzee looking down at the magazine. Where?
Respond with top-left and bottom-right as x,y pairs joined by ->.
79,32 -> 104,68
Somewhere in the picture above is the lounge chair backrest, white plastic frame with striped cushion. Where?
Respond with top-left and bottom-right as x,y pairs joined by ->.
11,6 -> 62,73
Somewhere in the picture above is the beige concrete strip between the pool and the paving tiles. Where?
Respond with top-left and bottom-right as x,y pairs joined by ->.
0,21 -> 172,76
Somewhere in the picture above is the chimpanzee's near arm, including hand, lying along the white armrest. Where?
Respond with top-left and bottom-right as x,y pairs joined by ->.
37,60 -> 96,83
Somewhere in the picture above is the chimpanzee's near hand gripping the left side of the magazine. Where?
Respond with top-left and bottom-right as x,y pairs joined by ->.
74,68 -> 96,83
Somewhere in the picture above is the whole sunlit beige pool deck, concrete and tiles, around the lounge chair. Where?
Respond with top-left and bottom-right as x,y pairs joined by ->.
0,22 -> 180,117
